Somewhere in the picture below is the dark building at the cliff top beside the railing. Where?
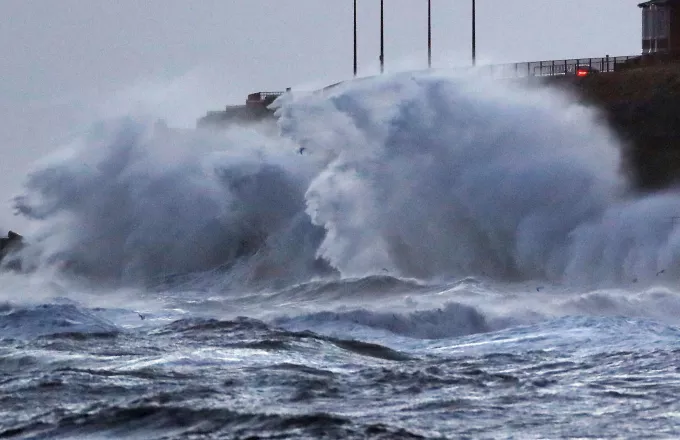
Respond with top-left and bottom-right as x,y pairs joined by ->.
638,0 -> 680,54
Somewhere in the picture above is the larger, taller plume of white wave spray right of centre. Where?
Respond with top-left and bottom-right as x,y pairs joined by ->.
279,71 -> 678,282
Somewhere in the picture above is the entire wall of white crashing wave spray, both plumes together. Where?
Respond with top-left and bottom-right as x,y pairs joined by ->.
11,74 -> 680,283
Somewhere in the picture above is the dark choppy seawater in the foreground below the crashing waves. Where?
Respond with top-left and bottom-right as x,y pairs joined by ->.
0,281 -> 680,439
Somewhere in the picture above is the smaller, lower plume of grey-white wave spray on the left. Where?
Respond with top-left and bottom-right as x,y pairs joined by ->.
17,120 -> 326,281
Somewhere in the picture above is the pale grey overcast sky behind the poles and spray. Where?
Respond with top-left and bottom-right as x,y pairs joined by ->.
0,0 -> 641,230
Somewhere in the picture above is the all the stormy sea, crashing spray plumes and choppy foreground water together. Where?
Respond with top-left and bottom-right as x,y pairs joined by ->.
0,73 -> 680,439
